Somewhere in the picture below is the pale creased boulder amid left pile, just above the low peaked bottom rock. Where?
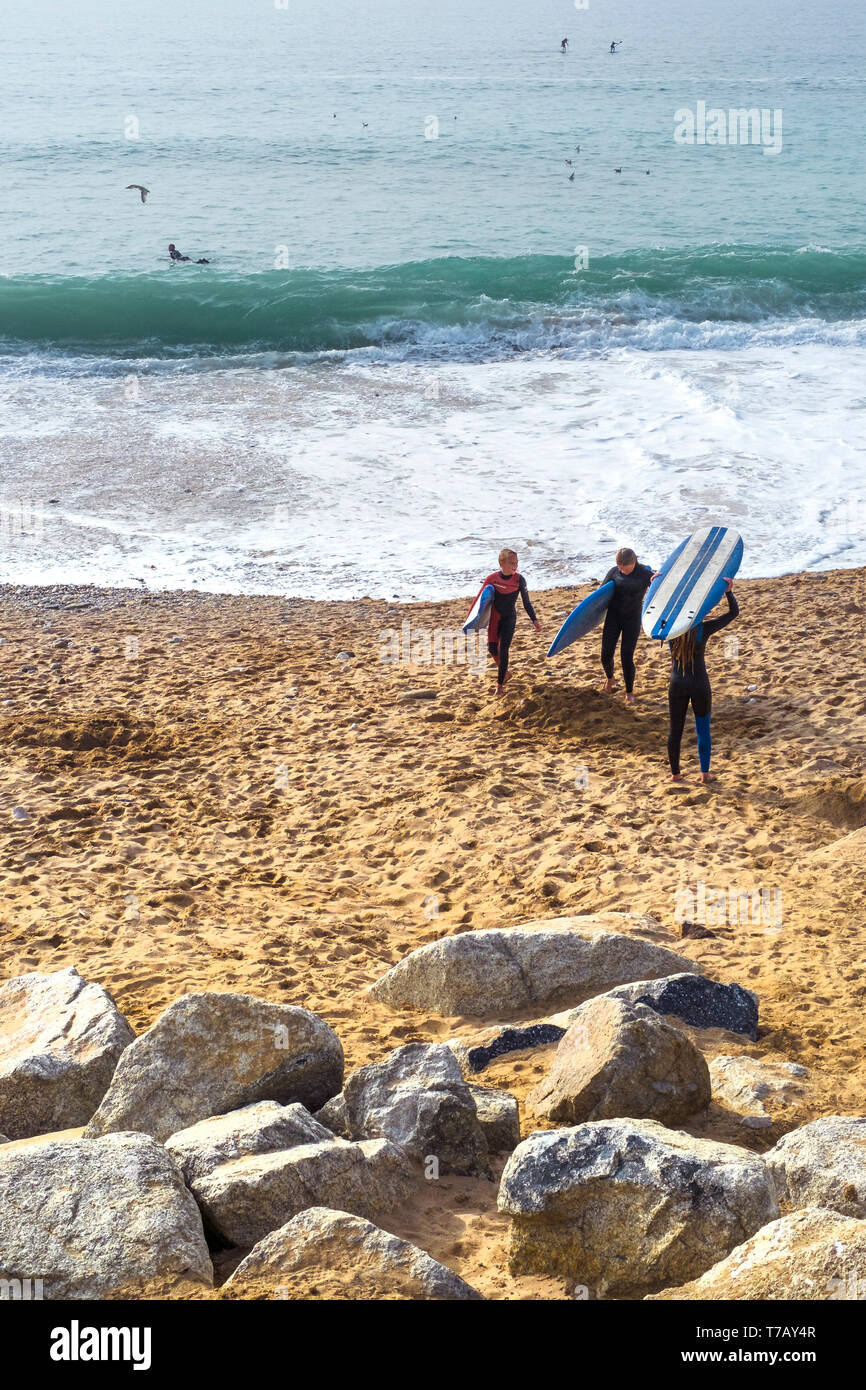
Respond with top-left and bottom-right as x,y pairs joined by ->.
165,1101 -> 416,1245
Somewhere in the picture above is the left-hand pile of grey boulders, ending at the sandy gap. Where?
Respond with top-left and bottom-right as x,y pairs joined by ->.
0,970 -> 500,1298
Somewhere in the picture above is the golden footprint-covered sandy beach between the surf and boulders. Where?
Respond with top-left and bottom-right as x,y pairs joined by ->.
0,558 -> 866,1298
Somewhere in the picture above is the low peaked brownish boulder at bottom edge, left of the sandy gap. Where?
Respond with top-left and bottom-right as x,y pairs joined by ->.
224,1207 -> 481,1301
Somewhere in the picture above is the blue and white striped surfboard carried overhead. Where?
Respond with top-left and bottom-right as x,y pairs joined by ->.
642,525 -> 742,642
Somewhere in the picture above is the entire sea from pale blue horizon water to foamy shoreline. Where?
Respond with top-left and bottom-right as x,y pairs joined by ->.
0,0 -> 866,598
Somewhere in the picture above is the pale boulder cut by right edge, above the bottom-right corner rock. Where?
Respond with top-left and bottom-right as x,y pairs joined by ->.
763,1115 -> 866,1212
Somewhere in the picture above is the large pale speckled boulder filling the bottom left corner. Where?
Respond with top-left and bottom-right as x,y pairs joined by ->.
0,1134 -> 213,1300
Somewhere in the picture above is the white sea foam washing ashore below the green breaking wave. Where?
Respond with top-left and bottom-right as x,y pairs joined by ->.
0,343 -> 866,598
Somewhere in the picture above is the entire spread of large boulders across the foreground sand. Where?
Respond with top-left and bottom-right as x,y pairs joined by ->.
0,915 -> 866,1300
